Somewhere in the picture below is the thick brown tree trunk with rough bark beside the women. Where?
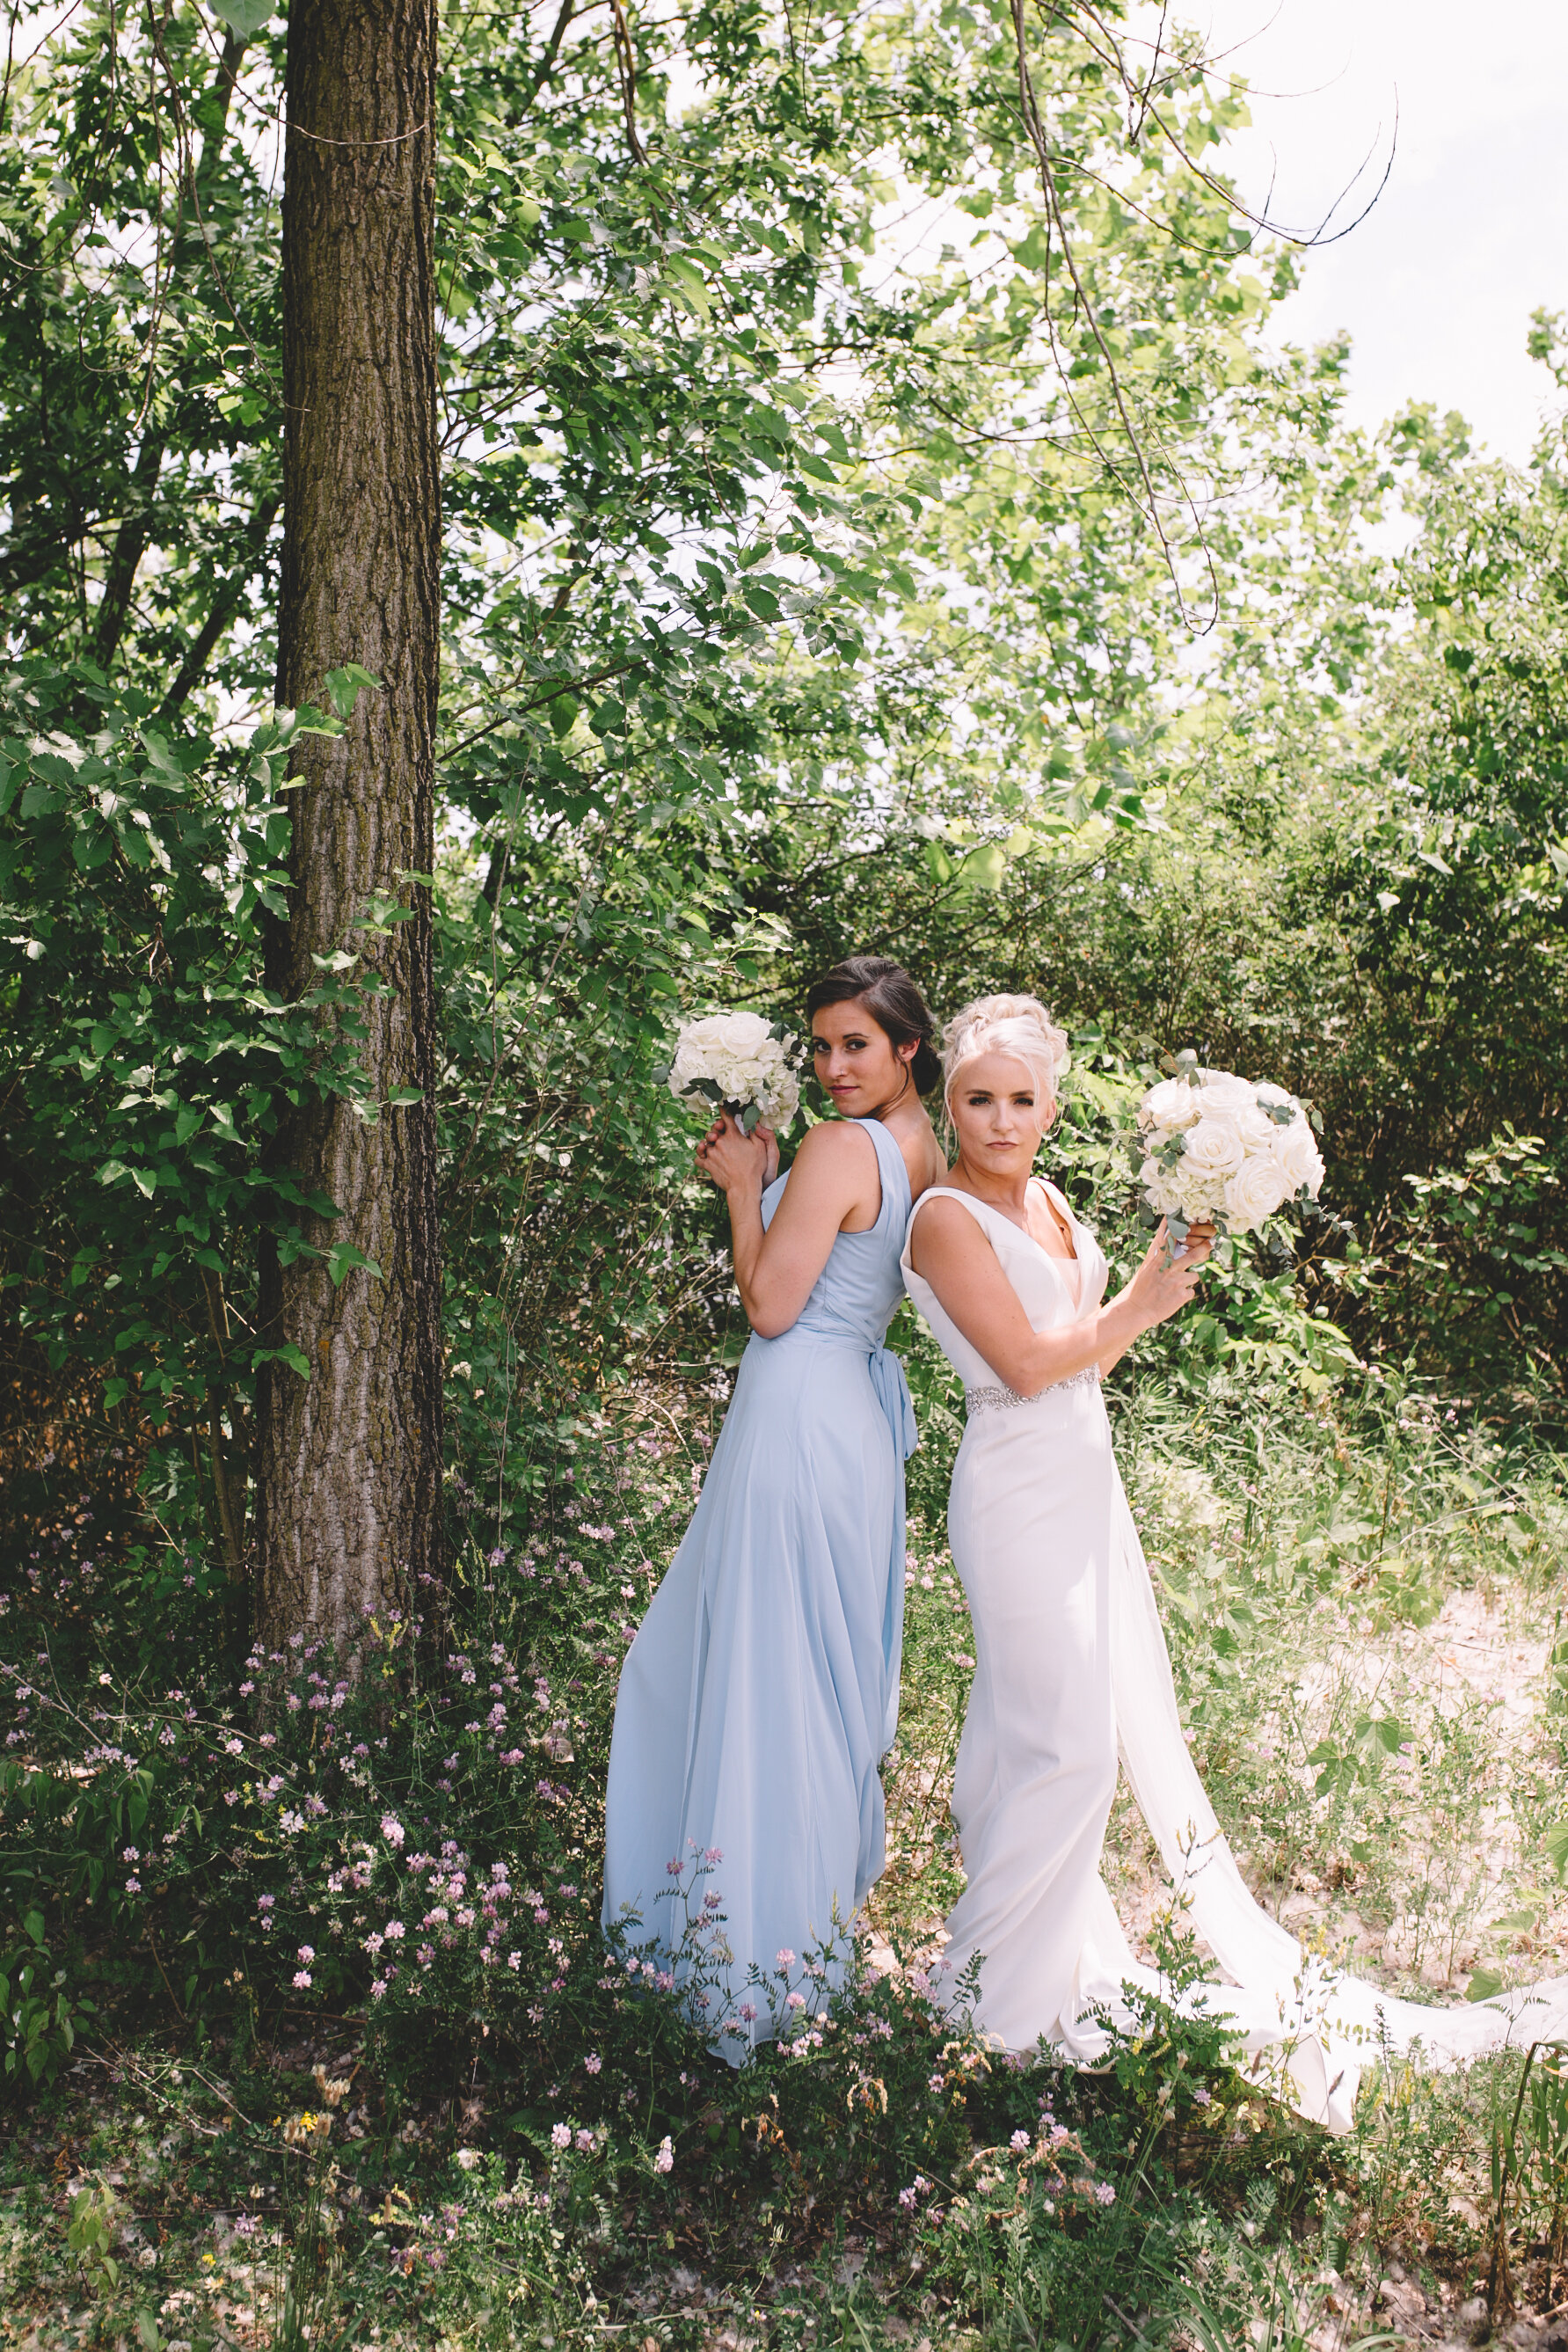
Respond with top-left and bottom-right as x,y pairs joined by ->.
256,0 -> 442,1651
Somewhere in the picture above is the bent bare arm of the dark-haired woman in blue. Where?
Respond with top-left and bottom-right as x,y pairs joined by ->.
696,1117 -> 881,1339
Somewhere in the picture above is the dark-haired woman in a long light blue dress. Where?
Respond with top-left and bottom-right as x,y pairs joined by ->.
604,957 -> 945,2065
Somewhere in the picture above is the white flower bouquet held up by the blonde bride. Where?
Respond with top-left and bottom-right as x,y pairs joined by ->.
1133,1051 -> 1324,1246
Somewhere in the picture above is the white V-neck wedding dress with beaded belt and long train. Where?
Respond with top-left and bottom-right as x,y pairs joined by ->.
902,1179 -> 1568,2131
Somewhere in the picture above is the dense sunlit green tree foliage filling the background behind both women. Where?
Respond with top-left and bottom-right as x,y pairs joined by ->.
0,7 -> 1568,1564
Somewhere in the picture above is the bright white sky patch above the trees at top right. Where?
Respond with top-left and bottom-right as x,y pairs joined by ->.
1173,0 -> 1568,458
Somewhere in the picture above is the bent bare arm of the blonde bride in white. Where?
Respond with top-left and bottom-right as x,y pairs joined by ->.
910,1197 -> 1208,1397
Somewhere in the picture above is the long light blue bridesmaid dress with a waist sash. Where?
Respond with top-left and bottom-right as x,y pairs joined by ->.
604,1120 -> 915,2065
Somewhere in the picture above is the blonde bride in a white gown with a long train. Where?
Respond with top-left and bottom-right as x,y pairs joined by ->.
902,997 -> 1568,2131
